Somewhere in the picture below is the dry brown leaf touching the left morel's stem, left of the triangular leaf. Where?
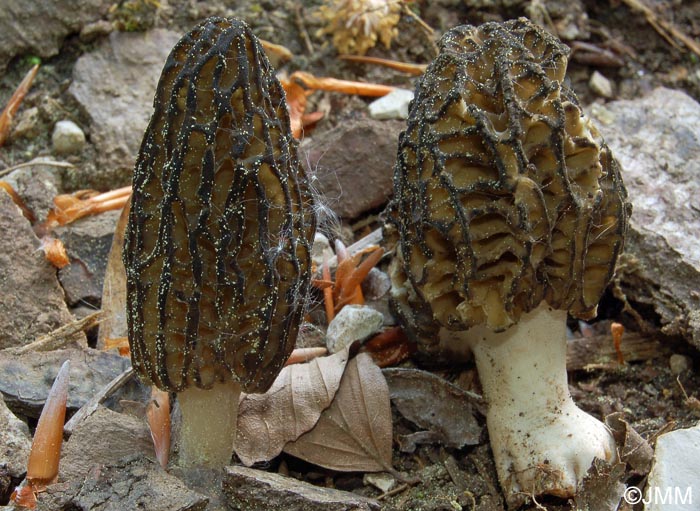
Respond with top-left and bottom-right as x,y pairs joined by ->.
236,349 -> 348,466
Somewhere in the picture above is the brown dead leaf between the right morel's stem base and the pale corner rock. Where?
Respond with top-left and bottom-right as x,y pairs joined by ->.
574,458 -> 625,511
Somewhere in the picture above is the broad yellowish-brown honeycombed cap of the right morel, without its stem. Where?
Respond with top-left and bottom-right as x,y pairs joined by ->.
386,18 -> 631,339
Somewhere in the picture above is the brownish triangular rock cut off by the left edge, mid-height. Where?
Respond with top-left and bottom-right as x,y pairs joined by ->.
0,192 -> 78,349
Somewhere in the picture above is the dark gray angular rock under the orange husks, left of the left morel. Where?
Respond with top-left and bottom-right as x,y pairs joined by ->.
54,211 -> 121,306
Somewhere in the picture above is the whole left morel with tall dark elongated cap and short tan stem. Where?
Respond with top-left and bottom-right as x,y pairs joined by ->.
124,18 -> 315,466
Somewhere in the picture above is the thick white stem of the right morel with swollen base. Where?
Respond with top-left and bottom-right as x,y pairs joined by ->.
463,304 -> 616,500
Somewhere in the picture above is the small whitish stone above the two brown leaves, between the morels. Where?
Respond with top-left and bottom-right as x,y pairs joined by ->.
326,305 -> 384,353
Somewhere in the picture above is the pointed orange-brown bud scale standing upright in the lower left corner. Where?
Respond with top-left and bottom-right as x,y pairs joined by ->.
27,360 -> 70,491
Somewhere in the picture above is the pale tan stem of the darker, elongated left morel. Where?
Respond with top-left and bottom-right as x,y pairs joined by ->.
177,382 -> 241,468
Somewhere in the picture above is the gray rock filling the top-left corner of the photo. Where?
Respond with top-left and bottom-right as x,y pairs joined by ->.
0,0 -> 112,71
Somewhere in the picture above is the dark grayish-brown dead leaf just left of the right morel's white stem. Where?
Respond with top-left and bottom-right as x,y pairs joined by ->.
383,368 -> 485,449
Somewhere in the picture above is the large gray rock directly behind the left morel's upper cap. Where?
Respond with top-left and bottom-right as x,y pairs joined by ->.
69,29 -> 180,190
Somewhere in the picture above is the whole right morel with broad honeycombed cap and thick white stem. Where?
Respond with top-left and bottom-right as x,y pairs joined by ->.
386,19 -> 631,502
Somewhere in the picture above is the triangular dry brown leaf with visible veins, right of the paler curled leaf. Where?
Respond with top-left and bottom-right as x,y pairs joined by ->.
284,353 -> 393,472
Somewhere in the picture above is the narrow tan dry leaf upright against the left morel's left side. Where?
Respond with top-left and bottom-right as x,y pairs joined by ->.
97,201 -> 131,349
